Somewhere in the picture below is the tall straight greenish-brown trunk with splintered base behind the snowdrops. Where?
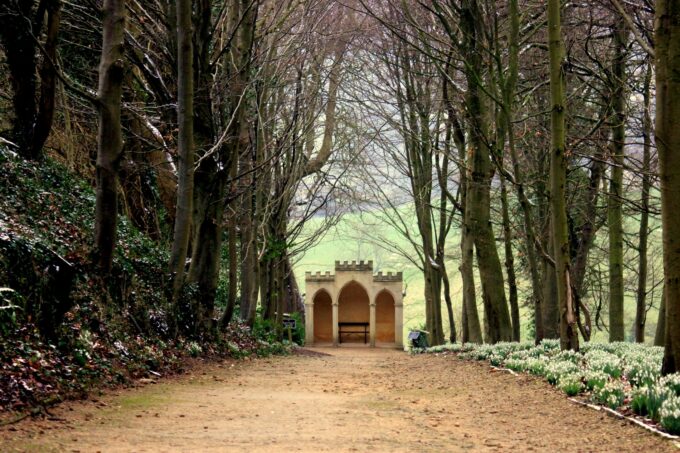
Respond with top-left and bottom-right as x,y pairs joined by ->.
548,0 -> 579,351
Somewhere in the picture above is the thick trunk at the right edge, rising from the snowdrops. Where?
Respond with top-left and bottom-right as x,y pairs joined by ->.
654,0 -> 680,375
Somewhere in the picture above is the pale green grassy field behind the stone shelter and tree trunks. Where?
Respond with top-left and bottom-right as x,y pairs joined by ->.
294,203 -> 661,342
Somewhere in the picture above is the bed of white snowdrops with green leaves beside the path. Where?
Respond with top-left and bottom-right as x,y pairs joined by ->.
424,340 -> 680,433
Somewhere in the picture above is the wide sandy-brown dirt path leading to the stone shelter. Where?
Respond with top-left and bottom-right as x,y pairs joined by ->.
0,348 -> 677,452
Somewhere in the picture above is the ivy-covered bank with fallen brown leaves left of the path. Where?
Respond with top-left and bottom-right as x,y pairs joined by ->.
0,147 -> 289,418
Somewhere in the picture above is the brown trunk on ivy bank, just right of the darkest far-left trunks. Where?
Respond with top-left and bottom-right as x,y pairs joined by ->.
94,0 -> 125,275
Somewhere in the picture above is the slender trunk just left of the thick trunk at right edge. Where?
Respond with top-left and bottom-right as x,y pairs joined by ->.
635,64 -> 652,343
